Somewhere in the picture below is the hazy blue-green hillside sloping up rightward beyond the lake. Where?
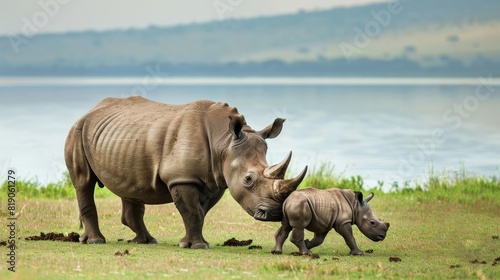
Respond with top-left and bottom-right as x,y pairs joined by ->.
0,0 -> 500,76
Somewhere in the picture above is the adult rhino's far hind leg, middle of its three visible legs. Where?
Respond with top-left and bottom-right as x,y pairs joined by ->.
122,198 -> 158,244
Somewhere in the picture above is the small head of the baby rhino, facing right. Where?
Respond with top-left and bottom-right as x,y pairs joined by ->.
353,192 -> 390,242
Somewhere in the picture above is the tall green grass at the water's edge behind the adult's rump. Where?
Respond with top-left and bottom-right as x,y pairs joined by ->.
0,172 -> 113,199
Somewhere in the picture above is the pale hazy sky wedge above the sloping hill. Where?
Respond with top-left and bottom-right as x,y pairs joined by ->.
0,0 -> 388,35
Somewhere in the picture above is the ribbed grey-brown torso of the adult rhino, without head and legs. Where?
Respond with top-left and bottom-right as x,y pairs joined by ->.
76,97 -> 237,203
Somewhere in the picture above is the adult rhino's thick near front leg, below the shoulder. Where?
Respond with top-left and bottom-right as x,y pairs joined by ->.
170,185 -> 209,249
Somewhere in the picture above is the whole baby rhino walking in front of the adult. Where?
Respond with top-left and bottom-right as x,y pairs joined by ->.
271,188 -> 389,255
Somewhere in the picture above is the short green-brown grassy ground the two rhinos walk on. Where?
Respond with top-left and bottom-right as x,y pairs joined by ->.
0,167 -> 500,279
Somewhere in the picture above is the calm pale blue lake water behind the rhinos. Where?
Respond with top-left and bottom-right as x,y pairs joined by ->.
0,77 -> 500,189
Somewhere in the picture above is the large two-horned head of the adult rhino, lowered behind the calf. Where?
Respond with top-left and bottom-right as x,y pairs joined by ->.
223,115 -> 307,221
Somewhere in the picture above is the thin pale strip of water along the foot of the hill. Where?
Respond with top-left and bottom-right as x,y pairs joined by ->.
0,76 -> 500,87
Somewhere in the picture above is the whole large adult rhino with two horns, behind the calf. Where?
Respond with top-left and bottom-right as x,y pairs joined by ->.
64,97 -> 307,248
